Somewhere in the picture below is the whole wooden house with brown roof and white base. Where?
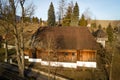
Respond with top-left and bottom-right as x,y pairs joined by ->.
25,27 -> 99,68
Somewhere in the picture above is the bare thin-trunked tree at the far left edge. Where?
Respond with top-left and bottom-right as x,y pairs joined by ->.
0,0 -> 11,62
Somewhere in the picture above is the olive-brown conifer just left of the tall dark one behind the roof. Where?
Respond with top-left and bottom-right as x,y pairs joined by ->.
62,6 -> 72,26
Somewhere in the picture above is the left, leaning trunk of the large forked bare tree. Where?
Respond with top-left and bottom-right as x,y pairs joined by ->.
9,0 -> 24,77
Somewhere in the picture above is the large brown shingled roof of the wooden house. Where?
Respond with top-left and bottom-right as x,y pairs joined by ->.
33,27 -> 98,50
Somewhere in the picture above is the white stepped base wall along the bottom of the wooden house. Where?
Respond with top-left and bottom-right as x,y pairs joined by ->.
25,56 -> 96,68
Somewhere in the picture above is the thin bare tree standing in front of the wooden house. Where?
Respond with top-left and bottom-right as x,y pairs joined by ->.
42,33 -> 58,80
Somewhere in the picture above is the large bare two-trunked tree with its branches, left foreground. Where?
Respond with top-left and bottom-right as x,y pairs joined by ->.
0,0 -> 33,77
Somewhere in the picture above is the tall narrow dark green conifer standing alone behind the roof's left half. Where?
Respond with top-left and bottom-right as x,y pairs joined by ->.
47,2 -> 55,26
